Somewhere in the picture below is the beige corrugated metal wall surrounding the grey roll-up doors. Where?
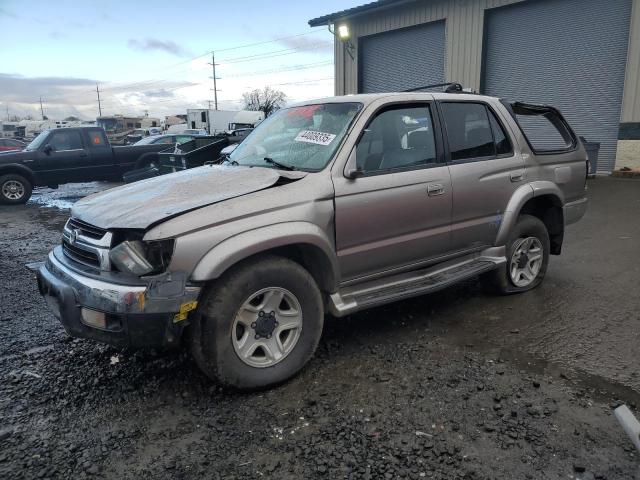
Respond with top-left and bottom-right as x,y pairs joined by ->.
335,0 -> 640,122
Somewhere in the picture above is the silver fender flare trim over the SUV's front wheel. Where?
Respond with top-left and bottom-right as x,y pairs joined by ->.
191,222 -> 339,289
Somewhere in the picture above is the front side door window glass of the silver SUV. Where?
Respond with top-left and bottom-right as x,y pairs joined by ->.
356,105 -> 437,172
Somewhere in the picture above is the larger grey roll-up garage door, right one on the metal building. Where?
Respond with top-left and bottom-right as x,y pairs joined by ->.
483,0 -> 632,172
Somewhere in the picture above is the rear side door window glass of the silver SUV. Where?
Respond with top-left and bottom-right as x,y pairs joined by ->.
442,102 -> 495,161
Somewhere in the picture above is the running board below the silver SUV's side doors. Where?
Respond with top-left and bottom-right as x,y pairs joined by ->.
329,257 -> 506,317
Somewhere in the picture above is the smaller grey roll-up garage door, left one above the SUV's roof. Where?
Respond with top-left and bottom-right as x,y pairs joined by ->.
359,22 -> 445,93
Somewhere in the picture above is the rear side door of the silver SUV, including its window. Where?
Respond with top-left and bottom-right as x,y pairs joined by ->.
438,101 -> 525,251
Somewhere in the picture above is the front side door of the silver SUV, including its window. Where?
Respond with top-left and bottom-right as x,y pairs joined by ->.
334,102 -> 451,281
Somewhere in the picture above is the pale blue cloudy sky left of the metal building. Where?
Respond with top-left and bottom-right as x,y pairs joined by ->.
0,0 -> 366,120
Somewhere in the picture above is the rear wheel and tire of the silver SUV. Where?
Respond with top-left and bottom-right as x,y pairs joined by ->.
481,215 -> 550,295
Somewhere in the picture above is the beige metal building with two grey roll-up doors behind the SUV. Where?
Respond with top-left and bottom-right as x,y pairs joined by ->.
309,0 -> 640,172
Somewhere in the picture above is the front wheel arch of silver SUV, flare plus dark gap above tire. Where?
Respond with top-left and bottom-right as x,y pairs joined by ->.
191,222 -> 339,293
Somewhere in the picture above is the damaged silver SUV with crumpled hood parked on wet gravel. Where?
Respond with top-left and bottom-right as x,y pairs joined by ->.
38,93 -> 588,389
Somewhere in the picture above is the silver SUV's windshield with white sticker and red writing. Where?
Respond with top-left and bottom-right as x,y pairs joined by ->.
229,102 -> 362,171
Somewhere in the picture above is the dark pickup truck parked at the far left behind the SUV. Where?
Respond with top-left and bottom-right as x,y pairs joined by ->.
0,127 -> 170,204
